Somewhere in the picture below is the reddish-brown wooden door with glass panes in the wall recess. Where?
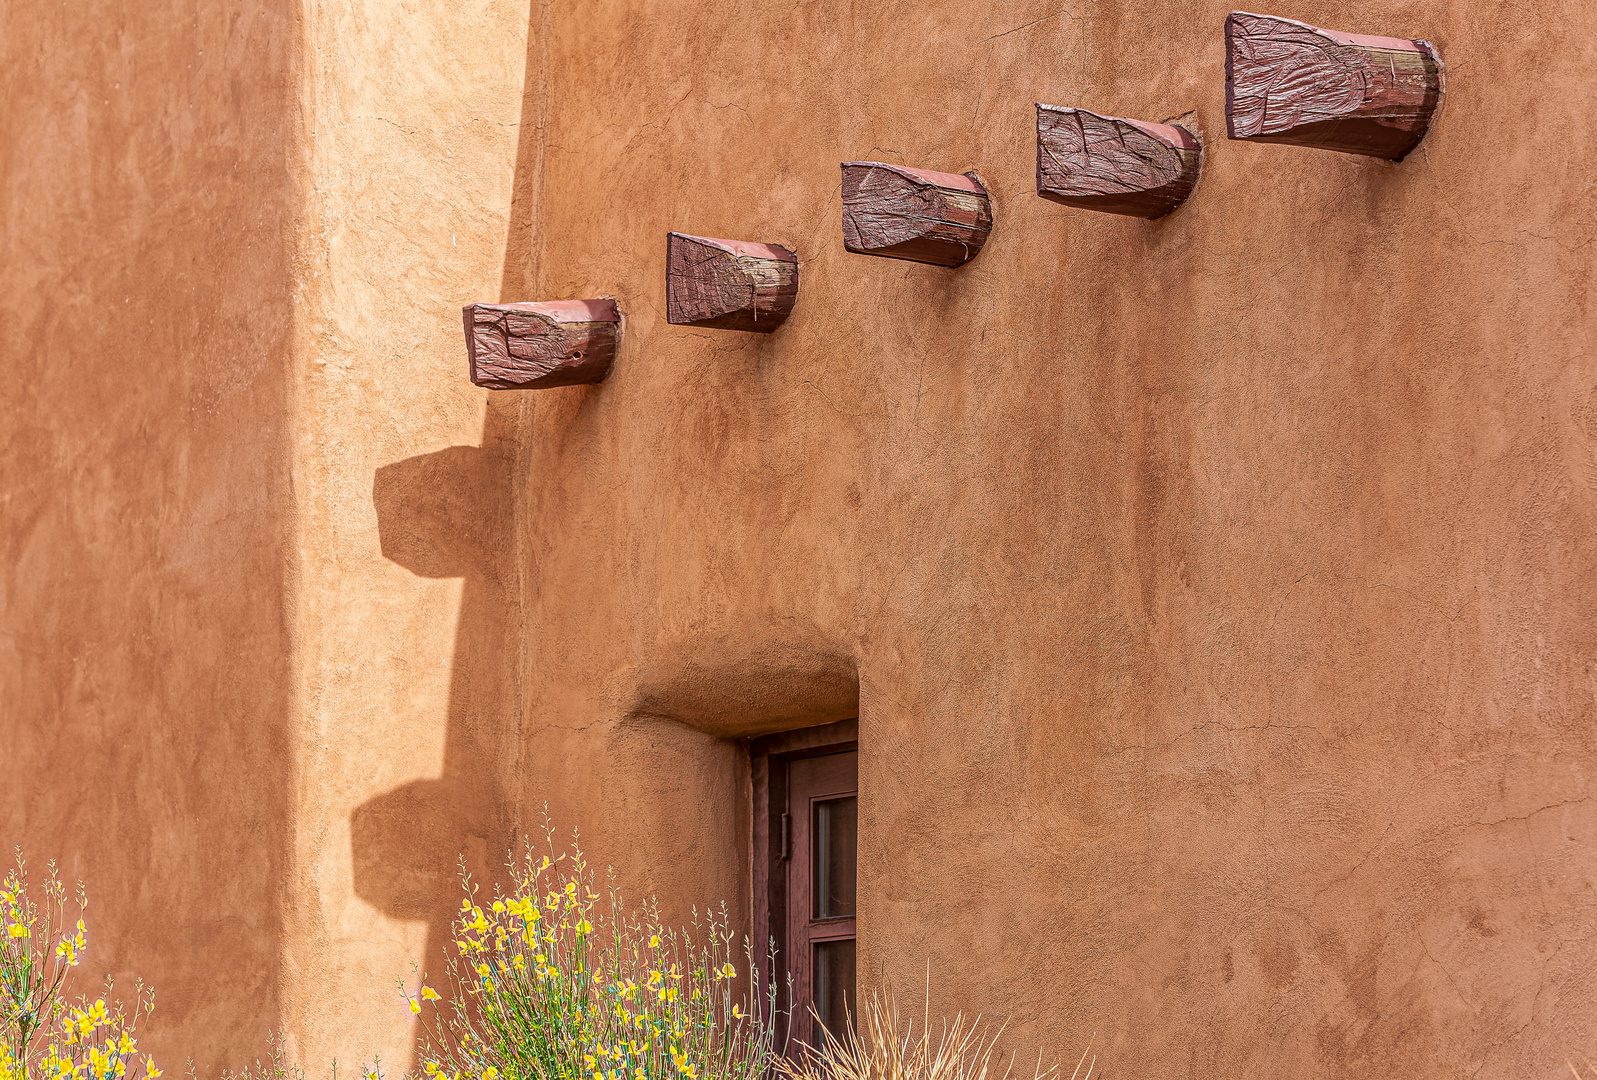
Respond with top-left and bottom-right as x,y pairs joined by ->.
786,751 -> 859,1045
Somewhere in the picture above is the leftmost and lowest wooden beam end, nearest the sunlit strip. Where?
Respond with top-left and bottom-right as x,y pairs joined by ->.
462,300 -> 621,390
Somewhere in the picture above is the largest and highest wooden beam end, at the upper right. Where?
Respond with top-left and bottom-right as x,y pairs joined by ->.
1225,11 -> 1442,161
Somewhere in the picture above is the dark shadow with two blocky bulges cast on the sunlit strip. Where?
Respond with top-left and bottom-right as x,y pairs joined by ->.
350,418 -> 522,975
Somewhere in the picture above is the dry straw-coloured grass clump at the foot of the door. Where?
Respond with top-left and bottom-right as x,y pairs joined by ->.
776,992 -> 1097,1080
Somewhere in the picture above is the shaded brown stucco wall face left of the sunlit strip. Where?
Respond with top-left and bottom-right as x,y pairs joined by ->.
0,0 -> 299,1074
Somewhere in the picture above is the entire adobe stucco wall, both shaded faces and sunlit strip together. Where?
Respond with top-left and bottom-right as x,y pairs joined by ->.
0,0 -> 1597,1077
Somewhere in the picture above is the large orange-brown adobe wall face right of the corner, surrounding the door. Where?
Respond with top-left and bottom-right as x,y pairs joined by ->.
511,0 -> 1597,1077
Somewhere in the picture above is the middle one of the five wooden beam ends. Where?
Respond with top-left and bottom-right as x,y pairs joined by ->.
843,161 -> 993,267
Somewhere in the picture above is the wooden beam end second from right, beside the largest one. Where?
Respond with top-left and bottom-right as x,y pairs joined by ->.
1036,104 -> 1203,217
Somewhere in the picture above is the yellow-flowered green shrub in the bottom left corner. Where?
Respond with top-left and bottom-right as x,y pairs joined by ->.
0,850 -> 161,1080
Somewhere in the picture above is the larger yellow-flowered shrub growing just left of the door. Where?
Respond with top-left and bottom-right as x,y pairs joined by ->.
407,842 -> 776,1080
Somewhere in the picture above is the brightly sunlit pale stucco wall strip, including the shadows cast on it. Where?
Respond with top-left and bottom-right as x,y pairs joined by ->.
283,0 -> 529,1069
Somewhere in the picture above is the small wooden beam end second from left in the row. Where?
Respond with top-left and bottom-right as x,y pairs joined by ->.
666,233 -> 799,334
